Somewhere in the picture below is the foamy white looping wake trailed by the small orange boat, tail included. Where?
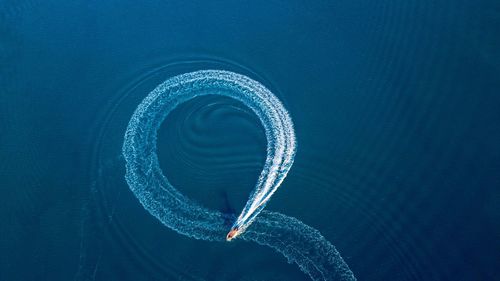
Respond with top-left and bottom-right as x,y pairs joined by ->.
123,70 -> 355,280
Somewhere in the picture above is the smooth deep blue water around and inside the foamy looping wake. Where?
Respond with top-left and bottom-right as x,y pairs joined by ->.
0,0 -> 500,281
